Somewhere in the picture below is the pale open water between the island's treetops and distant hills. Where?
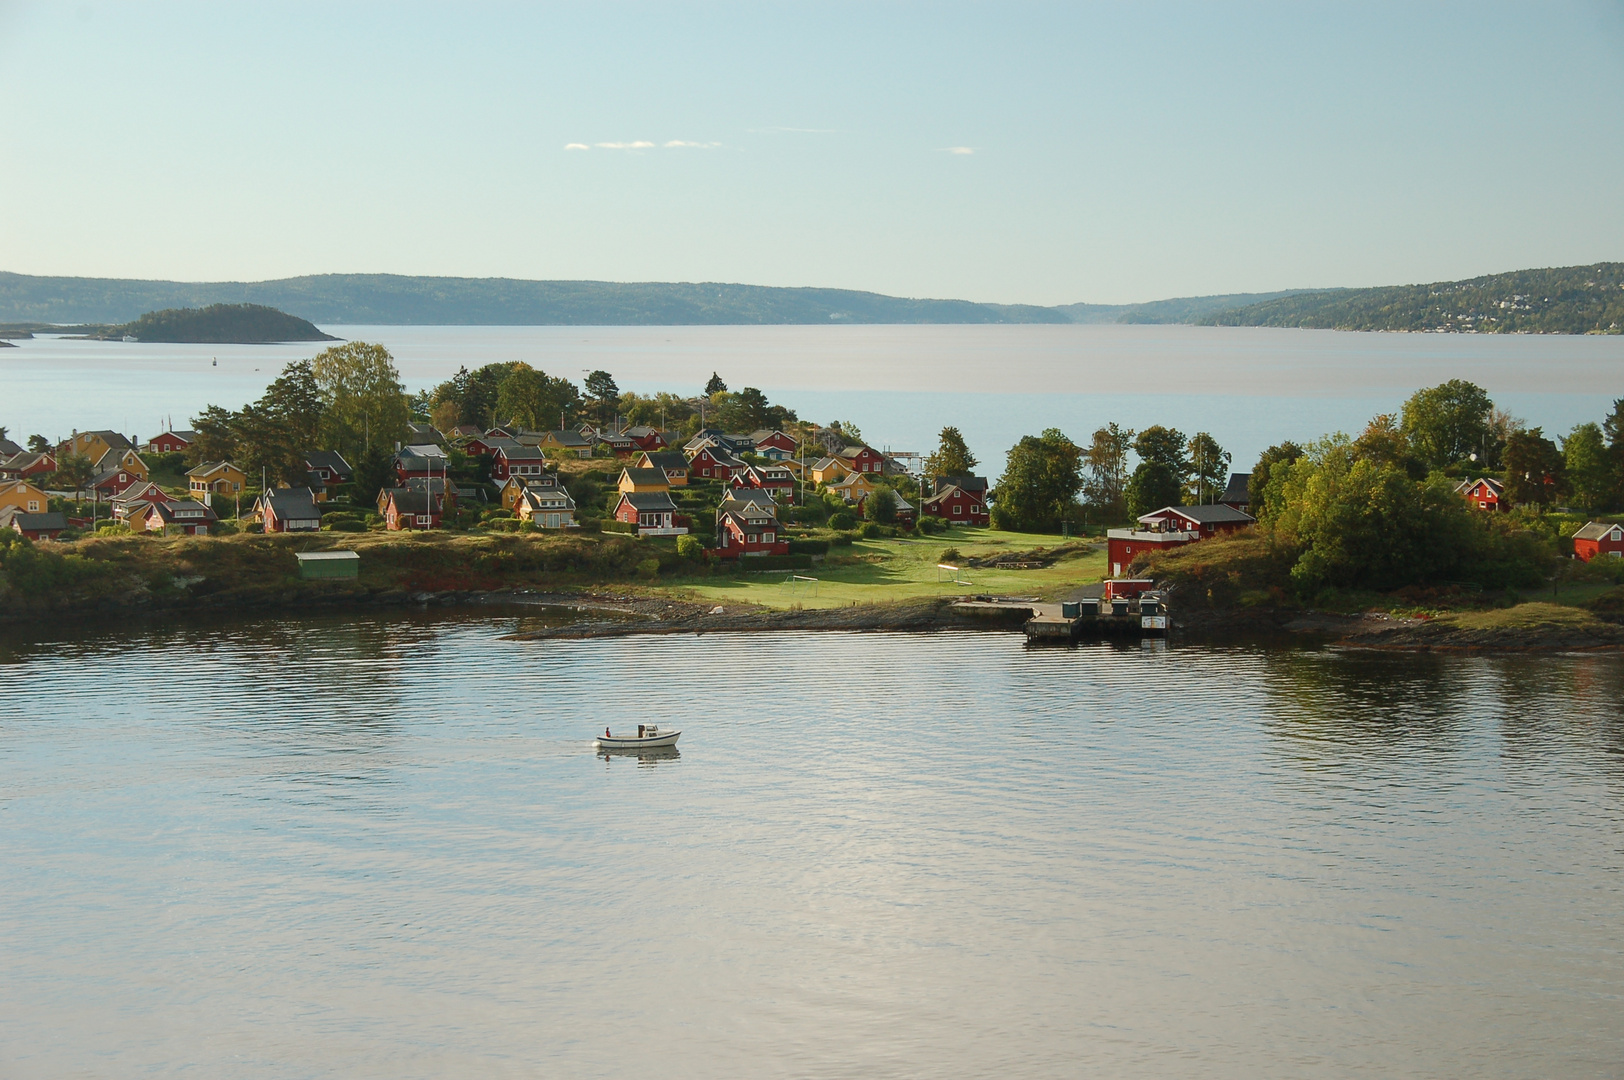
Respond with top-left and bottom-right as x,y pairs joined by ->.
0,325 -> 1624,476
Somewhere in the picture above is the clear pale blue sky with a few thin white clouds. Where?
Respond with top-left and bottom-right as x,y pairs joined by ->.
0,0 -> 1624,304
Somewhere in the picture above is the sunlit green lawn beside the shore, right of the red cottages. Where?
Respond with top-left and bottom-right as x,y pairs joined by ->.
667,528 -> 1106,607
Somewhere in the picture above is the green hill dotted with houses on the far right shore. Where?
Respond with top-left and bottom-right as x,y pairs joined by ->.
1197,263 -> 1624,335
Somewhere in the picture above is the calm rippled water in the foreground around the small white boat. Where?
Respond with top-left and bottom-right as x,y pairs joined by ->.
0,617 -> 1624,1077
